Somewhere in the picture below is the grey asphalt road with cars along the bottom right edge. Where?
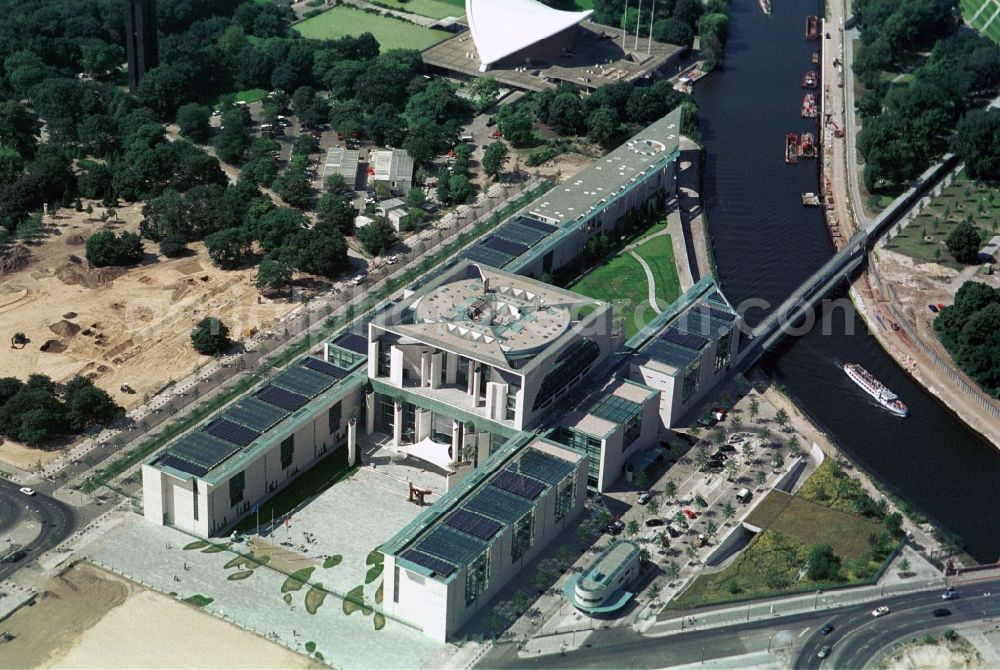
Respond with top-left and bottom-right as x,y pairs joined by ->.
477,580 -> 1000,669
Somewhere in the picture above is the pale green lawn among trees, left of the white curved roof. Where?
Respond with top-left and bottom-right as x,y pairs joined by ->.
295,5 -> 451,51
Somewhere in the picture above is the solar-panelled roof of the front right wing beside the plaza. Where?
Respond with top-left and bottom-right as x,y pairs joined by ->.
382,440 -> 582,581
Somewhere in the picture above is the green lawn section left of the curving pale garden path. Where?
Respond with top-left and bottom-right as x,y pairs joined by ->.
568,253 -> 656,339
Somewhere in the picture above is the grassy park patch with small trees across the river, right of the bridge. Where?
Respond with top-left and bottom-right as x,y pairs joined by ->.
886,170 -> 1000,270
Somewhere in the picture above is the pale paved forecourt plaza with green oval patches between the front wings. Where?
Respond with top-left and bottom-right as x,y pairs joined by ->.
87,454 -> 444,668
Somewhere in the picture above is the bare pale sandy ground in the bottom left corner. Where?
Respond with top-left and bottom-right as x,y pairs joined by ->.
0,563 -> 313,668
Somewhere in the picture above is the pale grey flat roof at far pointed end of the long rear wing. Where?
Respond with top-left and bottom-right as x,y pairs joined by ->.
527,107 -> 681,226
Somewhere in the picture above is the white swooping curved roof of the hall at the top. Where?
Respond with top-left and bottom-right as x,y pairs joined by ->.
465,0 -> 594,68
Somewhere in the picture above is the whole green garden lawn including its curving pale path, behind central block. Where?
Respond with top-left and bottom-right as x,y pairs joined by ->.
568,223 -> 680,339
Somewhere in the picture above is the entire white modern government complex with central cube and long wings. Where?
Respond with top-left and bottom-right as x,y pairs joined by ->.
142,110 -> 740,641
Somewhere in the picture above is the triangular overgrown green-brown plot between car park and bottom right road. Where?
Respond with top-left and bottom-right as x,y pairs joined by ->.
669,461 -> 896,609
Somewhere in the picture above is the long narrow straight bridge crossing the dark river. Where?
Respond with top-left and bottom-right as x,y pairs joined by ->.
736,154 -> 958,367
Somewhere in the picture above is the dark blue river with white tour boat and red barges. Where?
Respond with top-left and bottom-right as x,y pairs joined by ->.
695,0 -> 1000,562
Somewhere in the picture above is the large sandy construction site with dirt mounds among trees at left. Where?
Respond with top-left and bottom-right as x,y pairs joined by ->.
0,205 -> 294,408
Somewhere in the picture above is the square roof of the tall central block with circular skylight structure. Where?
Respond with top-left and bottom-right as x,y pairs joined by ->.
376,260 -> 611,369
